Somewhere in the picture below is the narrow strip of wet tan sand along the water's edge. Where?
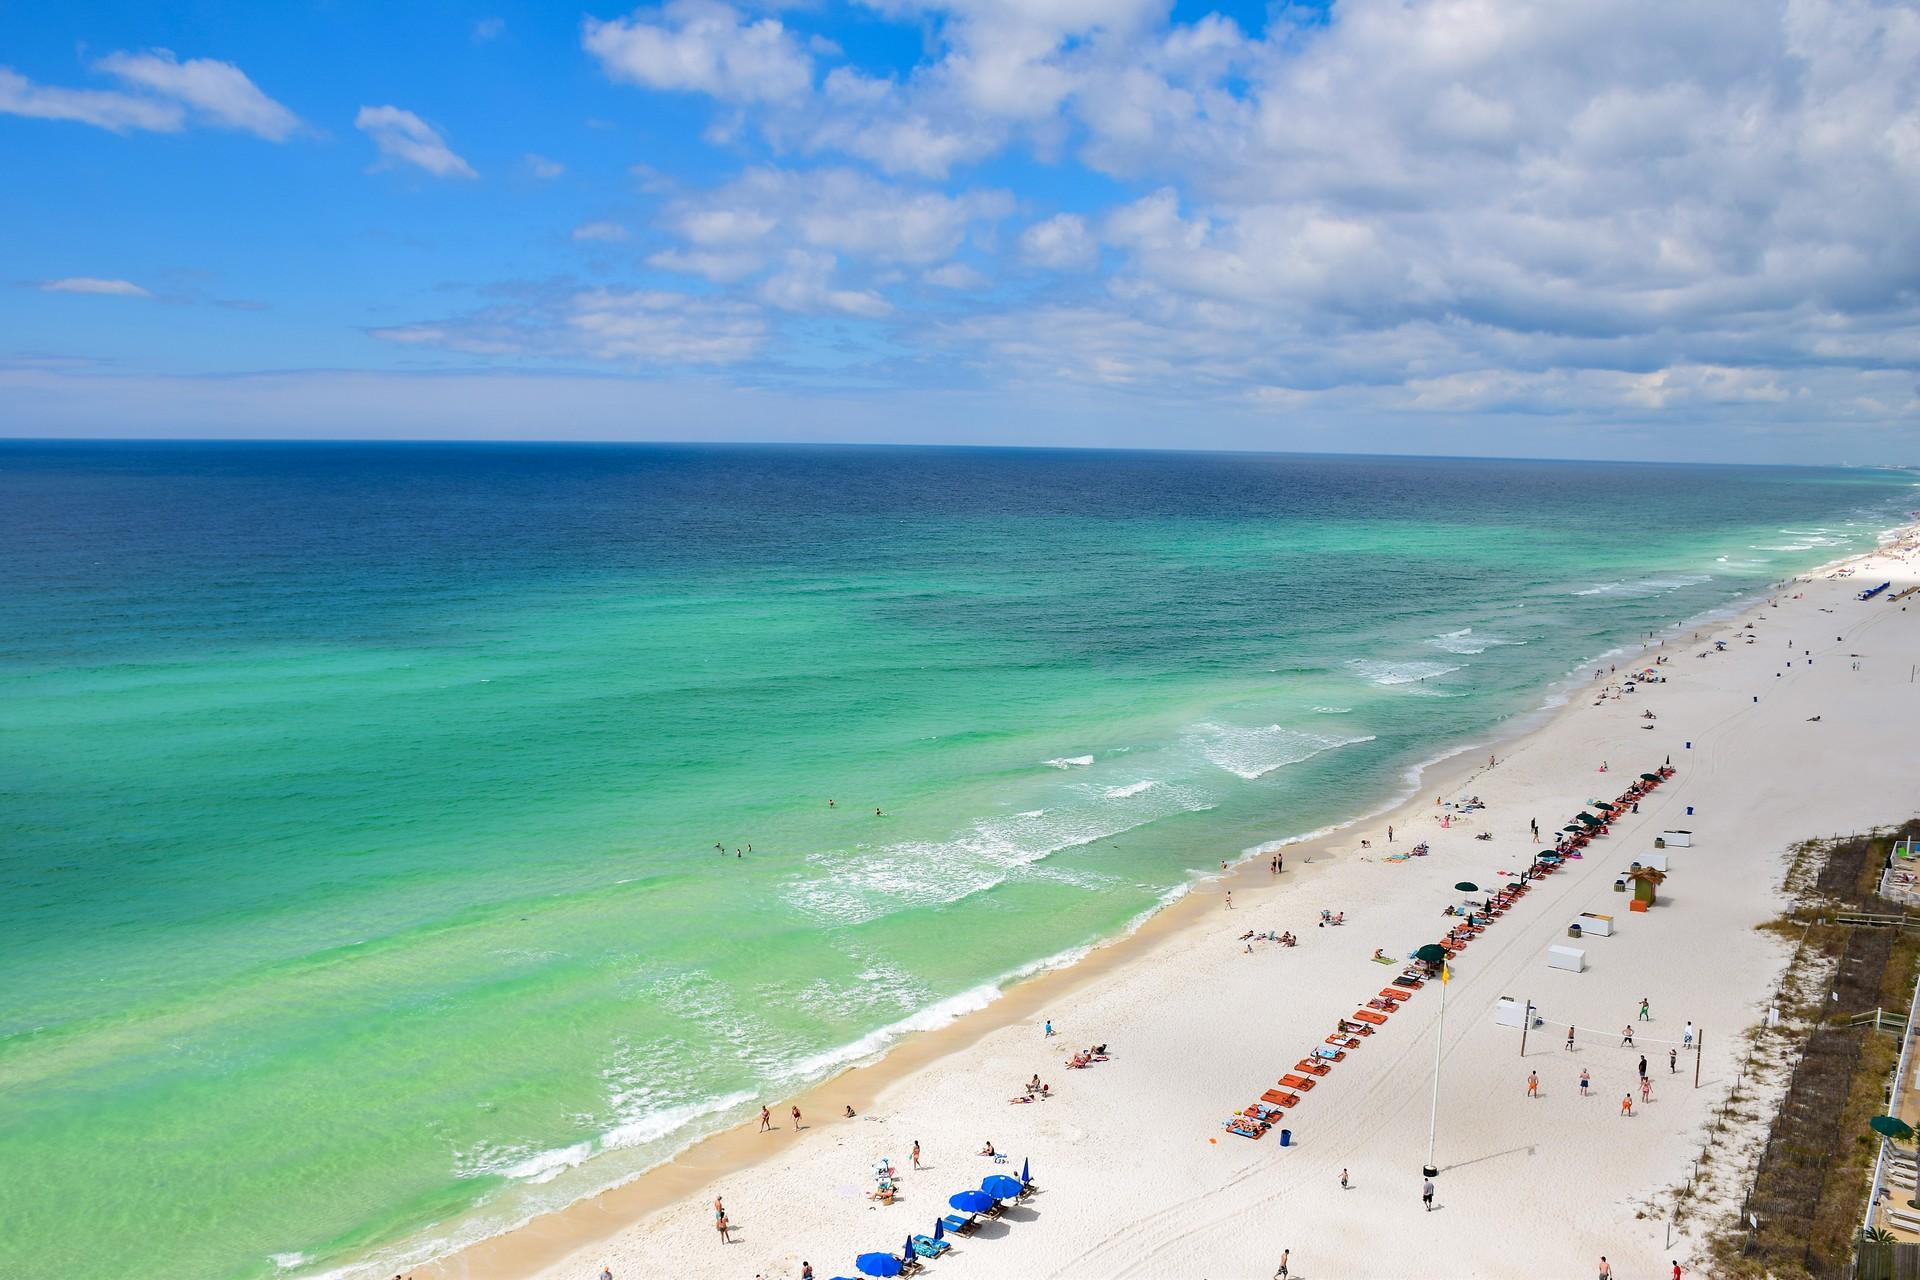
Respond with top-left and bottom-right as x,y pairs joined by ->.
408,524 -> 1920,1280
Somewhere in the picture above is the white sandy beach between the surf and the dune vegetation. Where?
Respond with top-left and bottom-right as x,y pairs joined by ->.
428,525 -> 1920,1280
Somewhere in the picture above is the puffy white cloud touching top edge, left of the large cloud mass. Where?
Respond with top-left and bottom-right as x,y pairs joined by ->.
582,0 -> 814,102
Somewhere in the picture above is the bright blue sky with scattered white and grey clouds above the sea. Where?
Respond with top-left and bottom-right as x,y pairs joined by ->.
0,0 -> 1920,462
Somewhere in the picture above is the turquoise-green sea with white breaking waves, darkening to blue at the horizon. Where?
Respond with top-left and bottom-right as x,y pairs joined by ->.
0,443 -> 1914,1280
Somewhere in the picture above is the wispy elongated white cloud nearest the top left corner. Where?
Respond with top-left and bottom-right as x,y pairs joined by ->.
0,48 -> 300,142
